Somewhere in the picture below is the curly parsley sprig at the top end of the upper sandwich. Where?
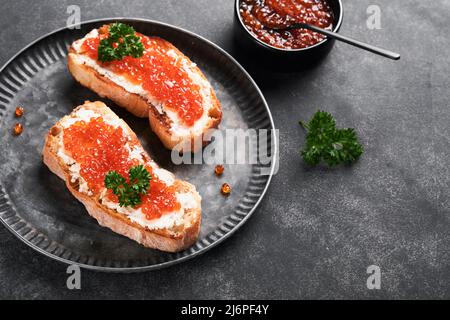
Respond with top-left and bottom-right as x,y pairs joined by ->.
98,22 -> 144,62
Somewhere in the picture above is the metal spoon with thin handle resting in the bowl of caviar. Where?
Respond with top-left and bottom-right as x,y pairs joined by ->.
265,23 -> 400,60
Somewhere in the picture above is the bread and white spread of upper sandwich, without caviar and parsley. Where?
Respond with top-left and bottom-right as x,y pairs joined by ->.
67,26 -> 222,152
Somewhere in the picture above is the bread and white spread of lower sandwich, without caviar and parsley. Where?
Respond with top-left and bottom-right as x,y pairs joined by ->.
42,101 -> 201,252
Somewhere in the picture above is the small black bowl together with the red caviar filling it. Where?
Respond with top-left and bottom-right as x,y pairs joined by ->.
234,0 -> 343,63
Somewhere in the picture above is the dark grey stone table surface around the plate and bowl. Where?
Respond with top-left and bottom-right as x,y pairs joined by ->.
0,0 -> 450,299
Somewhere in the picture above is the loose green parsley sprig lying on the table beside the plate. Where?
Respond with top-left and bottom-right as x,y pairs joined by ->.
300,111 -> 363,166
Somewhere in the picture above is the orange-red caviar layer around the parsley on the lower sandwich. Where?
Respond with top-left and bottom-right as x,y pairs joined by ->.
63,117 -> 180,220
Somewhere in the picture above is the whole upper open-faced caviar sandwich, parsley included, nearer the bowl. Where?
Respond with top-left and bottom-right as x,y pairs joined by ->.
68,23 -> 222,151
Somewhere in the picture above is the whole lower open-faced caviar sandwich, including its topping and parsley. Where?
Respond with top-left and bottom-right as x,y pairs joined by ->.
42,102 -> 201,252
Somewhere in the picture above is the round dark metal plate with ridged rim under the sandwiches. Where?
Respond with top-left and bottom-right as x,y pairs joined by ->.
0,18 -> 277,271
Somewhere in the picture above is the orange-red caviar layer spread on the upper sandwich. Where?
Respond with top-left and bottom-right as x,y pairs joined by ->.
81,29 -> 203,126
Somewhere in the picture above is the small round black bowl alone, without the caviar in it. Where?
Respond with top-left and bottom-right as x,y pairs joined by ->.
234,0 -> 344,68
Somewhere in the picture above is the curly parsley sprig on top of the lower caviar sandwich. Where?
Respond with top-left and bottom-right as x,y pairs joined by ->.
105,165 -> 152,207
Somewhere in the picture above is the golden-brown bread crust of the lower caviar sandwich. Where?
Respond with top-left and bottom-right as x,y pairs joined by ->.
42,102 -> 201,252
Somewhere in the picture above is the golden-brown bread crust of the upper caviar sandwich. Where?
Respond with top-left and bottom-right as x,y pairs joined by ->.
67,32 -> 222,152
